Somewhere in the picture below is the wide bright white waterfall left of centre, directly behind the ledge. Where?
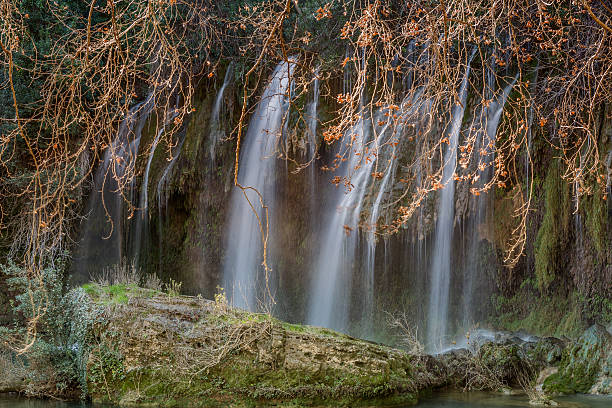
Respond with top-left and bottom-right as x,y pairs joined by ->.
223,57 -> 296,310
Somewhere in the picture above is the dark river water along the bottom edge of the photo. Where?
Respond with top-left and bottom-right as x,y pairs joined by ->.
0,392 -> 612,408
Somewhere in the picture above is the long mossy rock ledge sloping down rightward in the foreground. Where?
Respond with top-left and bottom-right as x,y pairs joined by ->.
85,284 -> 447,407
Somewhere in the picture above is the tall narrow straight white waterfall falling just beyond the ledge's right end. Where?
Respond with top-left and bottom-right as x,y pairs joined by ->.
427,49 -> 476,349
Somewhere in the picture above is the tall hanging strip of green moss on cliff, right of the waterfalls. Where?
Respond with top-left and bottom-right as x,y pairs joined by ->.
534,160 -> 570,291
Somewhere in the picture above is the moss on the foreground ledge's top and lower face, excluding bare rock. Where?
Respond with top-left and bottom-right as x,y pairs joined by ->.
84,284 -> 422,407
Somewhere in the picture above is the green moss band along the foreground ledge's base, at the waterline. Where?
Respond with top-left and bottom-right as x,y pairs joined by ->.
89,347 -> 416,407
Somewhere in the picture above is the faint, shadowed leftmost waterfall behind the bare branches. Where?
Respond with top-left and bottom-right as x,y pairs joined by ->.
73,93 -> 154,281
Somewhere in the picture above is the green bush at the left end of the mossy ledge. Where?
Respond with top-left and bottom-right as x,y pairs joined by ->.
0,257 -> 97,398
